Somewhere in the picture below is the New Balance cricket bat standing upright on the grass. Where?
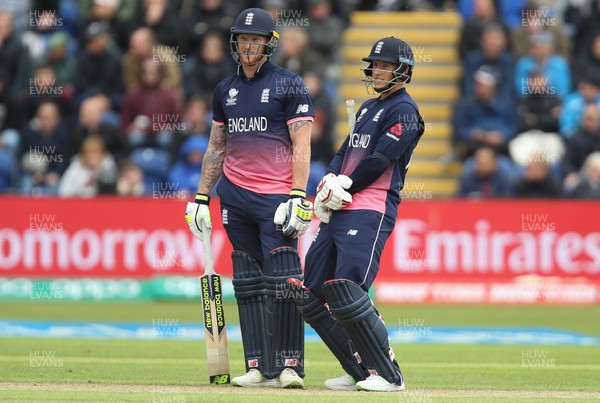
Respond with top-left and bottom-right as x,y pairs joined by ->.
200,222 -> 230,385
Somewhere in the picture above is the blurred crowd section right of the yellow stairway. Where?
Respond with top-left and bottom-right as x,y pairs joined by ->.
454,0 -> 600,198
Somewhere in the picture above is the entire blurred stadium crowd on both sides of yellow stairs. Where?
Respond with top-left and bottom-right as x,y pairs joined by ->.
0,0 -> 600,198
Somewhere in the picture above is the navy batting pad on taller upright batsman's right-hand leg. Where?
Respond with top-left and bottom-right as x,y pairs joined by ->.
263,247 -> 304,378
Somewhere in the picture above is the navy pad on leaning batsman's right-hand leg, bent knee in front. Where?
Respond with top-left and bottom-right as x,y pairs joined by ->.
321,279 -> 402,383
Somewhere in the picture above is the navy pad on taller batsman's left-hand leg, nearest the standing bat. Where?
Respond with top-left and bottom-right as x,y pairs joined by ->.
231,251 -> 269,376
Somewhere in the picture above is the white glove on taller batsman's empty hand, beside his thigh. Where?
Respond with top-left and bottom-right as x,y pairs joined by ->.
273,189 -> 313,238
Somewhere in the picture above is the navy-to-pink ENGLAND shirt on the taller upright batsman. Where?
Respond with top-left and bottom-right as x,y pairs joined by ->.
212,60 -> 314,194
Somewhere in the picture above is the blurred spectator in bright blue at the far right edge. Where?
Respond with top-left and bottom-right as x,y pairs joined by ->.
558,71 -> 600,139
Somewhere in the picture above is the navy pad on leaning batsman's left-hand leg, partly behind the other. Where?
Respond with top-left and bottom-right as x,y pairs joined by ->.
289,279 -> 368,382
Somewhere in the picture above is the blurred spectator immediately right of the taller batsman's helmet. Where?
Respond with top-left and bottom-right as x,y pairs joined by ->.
273,28 -> 327,75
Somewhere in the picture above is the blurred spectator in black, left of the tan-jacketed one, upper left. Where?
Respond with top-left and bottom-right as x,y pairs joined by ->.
77,22 -> 122,105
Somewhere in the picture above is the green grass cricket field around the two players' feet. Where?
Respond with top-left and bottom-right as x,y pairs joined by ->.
0,302 -> 600,403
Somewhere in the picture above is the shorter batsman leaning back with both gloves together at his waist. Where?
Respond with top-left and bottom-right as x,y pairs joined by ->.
289,36 -> 424,391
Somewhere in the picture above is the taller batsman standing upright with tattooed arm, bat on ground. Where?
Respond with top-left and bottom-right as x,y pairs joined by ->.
185,8 -> 314,388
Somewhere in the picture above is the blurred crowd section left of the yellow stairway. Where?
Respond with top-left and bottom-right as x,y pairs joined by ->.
0,0 -> 349,197
